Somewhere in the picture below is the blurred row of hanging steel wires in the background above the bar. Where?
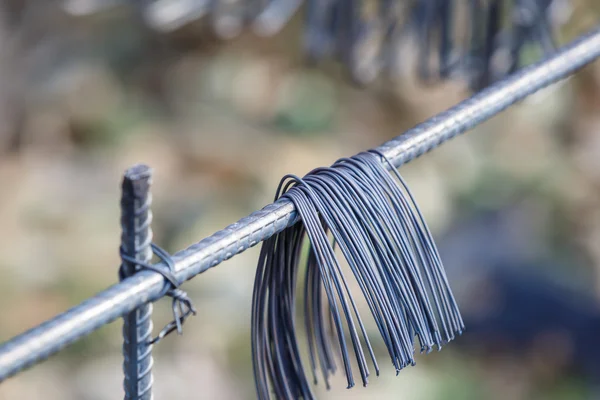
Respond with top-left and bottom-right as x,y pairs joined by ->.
129,0 -> 568,89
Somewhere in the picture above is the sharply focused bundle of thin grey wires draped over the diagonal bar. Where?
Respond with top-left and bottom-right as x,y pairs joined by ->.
251,151 -> 464,399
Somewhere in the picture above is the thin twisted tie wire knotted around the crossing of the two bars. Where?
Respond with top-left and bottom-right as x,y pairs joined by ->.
119,243 -> 196,345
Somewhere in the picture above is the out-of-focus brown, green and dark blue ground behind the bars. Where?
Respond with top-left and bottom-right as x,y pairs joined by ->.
0,0 -> 600,400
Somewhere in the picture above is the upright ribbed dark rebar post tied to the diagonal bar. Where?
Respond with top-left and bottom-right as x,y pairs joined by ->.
120,164 -> 153,400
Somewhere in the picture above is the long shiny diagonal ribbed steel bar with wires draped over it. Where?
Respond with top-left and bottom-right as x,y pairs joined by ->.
0,28 -> 600,381
